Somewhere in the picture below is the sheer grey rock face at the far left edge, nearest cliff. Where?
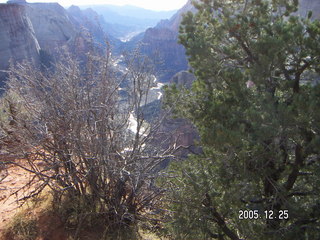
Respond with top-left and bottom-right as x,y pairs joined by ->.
0,4 -> 40,83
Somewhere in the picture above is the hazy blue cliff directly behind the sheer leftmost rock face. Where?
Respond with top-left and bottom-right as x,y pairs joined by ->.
27,3 -> 118,56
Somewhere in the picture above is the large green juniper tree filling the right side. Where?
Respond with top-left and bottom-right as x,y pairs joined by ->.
166,0 -> 320,240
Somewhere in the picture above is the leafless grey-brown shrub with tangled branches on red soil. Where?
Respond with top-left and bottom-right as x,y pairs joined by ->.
1,47 -> 173,236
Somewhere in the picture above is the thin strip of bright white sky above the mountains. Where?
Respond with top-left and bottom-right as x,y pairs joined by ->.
0,0 -> 187,10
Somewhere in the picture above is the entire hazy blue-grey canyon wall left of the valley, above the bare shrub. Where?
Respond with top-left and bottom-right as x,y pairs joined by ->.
0,0 -> 120,85
